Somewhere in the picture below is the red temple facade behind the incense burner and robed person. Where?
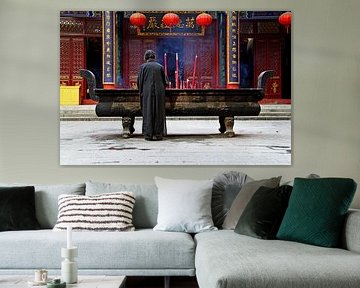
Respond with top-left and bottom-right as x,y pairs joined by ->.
60,11 -> 291,104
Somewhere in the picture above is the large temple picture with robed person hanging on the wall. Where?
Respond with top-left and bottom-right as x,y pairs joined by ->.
59,11 -> 292,165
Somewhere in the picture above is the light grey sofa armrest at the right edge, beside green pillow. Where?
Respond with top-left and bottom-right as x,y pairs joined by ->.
343,209 -> 360,253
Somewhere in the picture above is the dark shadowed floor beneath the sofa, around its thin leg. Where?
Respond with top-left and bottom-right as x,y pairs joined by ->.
126,276 -> 199,288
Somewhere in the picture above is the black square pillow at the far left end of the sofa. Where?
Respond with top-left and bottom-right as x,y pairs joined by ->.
0,186 -> 40,231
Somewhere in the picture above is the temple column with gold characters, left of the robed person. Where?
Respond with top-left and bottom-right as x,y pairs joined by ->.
102,11 -> 115,89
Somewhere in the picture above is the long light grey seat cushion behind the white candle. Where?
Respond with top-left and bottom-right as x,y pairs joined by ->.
0,229 -> 195,270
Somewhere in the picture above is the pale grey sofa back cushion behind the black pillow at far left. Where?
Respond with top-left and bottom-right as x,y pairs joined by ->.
0,183 -> 85,229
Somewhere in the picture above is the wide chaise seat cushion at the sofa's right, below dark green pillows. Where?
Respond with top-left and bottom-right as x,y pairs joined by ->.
195,230 -> 360,288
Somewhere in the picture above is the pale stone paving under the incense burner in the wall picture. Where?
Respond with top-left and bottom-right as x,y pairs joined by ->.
60,119 -> 291,165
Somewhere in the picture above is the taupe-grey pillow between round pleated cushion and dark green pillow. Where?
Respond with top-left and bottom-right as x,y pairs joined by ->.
222,176 -> 281,230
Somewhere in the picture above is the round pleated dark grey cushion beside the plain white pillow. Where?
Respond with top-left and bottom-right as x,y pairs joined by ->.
211,171 -> 253,228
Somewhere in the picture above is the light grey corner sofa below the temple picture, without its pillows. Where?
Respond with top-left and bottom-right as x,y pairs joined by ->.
0,182 -> 360,288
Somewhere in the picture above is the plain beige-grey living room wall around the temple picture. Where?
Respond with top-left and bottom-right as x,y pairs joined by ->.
0,0 -> 360,208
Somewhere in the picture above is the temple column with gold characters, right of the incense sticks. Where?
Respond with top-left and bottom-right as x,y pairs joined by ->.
226,11 -> 240,89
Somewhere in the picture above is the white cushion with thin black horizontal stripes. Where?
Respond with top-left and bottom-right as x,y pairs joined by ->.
54,192 -> 135,231
